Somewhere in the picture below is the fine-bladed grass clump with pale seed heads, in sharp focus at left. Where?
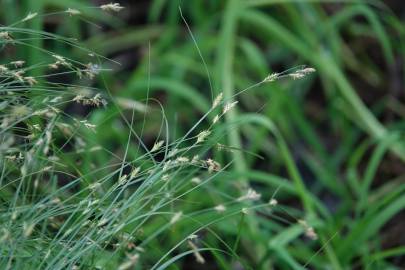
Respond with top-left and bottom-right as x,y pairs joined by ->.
0,3 -> 316,269
